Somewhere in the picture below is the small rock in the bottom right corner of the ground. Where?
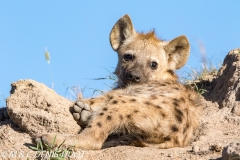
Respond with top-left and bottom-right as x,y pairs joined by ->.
222,141 -> 240,160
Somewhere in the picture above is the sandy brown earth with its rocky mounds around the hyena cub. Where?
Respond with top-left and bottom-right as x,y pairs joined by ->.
0,49 -> 240,160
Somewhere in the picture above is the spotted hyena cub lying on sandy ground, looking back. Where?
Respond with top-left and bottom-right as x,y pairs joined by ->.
35,15 -> 202,149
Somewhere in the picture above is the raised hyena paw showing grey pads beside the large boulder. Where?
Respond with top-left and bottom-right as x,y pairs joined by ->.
73,101 -> 92,127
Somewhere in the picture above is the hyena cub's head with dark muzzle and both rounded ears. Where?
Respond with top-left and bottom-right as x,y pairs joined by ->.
110,15 -> 190,87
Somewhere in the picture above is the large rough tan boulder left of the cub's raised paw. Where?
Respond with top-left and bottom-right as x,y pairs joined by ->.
7,80 -> 80,135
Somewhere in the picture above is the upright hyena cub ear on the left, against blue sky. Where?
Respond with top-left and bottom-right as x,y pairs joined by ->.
110,14 -> 136,51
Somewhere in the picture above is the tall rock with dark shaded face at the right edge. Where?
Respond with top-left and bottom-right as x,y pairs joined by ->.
210,48 -> 240,111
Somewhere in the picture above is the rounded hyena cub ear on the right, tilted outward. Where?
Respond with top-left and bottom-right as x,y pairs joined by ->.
164,36 -> 190,70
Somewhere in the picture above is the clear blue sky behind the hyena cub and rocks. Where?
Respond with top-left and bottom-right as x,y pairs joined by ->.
0,0 -> 240,107
